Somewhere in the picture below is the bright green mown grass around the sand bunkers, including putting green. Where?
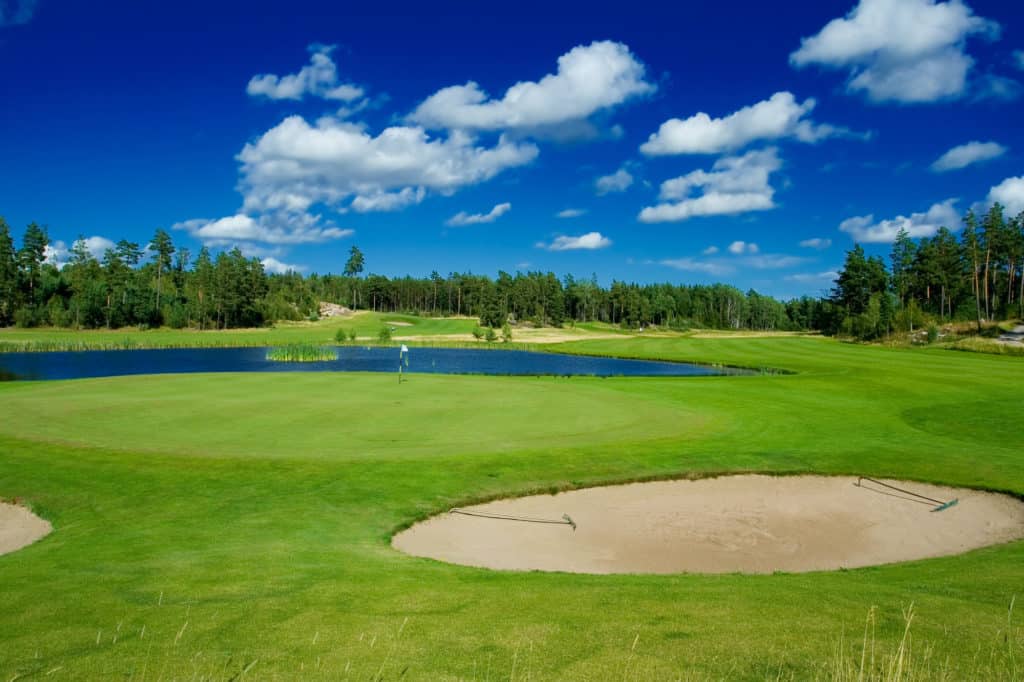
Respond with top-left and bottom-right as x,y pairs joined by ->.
0,333 -> 1024,682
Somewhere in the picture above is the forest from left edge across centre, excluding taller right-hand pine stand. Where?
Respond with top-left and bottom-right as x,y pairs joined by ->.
0,218 -> 833,330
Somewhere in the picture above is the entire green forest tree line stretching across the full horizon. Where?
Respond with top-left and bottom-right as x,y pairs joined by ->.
6,204 -> 1024,339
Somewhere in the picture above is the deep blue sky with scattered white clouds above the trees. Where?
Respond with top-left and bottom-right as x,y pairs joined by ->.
0,0 -> 1024,297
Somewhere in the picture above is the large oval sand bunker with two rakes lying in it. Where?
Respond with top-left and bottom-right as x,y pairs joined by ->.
392,475 -> 1024,573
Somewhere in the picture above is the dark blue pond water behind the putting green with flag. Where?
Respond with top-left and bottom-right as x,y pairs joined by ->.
0,346 -> 749,380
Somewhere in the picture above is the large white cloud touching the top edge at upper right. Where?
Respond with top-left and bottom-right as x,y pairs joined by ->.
790,0 -> 999,102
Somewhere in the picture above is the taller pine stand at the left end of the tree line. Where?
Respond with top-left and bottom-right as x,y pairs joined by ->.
0,217 -> 272,329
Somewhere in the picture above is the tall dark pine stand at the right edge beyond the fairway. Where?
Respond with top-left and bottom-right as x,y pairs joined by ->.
821,204 -> 1024,340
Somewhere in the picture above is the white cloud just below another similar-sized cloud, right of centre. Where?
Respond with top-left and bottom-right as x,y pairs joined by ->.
638,147 -> 782,222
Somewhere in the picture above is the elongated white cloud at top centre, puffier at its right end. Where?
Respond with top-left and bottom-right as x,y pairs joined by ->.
409,41 -> 655,132
